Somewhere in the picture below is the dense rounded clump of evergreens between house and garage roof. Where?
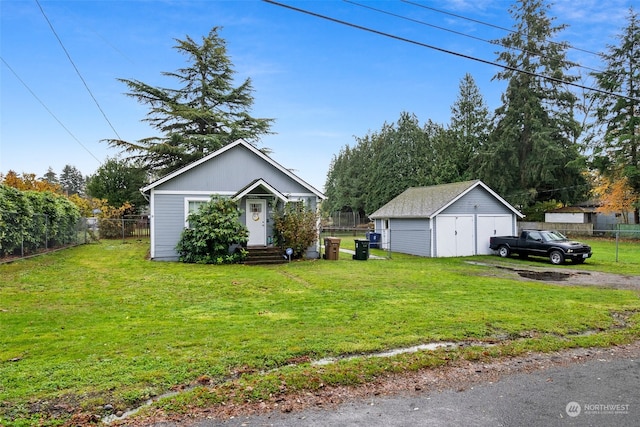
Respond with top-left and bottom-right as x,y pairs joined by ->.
323,112 -> 452,214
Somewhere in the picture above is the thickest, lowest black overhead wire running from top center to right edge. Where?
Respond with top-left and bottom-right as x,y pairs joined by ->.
262,0 -> 640,102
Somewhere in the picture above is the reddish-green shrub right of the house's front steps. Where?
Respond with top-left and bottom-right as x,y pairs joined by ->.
273,202 -> 318,258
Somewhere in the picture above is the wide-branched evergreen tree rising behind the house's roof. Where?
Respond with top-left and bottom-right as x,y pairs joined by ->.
107,27 -> 273,174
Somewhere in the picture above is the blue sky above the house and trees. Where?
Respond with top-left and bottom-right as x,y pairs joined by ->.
0,0 -> 635,190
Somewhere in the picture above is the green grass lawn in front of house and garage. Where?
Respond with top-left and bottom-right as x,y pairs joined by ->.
0,240 -> 640,425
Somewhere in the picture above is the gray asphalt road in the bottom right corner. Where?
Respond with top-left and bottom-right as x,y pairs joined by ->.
156,348 -> 640,427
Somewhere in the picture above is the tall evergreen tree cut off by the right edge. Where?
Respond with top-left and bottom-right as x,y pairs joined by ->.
593,9 -> 640,224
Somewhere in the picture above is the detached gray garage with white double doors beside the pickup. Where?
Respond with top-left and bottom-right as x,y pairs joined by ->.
369,180 -> 524,257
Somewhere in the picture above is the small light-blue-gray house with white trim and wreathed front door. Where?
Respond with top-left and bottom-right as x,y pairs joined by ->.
140,140 -> 326,261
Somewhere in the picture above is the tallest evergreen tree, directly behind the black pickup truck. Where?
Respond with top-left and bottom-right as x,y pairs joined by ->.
478,0 -> 586,206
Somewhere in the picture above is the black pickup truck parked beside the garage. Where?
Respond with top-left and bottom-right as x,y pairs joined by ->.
489,230 -> 591,265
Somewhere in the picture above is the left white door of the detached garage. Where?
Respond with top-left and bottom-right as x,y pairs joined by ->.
436,215 -> 475,257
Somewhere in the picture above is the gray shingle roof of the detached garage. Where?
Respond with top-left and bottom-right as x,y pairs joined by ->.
369,180 -> 484,219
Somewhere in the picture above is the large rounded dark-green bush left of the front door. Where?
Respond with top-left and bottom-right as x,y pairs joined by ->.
176,196 -> 249,264
